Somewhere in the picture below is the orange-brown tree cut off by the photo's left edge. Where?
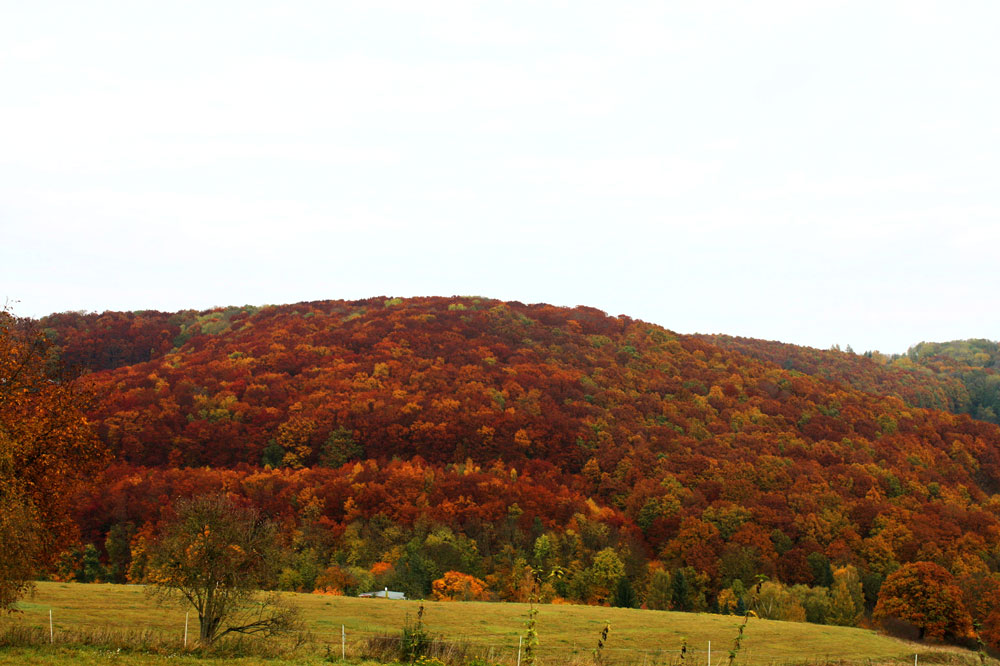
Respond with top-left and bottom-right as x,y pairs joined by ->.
0,309 -> 103,613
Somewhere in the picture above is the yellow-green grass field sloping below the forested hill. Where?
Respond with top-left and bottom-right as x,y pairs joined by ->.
0,583 -> 978,666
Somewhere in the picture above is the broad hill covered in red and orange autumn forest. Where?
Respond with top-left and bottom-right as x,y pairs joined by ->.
29,297 -> 1000,612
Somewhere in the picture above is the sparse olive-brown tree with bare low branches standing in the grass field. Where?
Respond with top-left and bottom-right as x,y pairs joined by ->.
147,495 -> 299,645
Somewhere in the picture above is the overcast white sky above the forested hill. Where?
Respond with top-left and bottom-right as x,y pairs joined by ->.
0,0 -> 1000,352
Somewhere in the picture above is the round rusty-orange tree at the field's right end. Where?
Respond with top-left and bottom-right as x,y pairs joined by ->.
872,562 -> 972,640
